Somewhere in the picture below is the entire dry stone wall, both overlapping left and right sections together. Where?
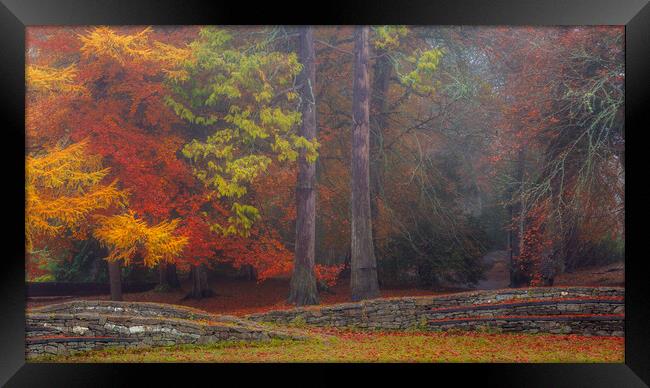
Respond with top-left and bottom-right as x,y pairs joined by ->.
26,287 -> 625,359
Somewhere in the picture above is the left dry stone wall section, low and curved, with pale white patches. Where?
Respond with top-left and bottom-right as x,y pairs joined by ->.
26,301 -> 304,358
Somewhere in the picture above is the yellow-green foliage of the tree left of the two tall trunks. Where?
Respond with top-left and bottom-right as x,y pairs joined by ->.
166,28 -> 318,298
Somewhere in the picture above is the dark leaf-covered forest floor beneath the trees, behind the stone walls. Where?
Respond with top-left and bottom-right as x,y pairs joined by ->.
27,258 -> 625,315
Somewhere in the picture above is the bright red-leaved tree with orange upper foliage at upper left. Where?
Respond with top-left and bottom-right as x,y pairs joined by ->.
27,27 -> 209,296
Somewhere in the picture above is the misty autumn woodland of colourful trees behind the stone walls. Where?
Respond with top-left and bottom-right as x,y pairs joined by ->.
25,26 -> 625,306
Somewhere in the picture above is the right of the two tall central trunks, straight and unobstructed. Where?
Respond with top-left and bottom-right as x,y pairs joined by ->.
350,27 -> 379,301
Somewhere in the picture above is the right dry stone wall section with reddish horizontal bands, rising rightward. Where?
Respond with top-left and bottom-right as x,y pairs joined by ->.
247,287 -> 624,336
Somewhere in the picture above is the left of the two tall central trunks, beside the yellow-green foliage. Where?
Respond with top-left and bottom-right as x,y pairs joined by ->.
289,27 -> 318,306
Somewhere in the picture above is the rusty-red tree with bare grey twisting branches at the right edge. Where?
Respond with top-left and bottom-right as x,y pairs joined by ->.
486,27 -> 624,286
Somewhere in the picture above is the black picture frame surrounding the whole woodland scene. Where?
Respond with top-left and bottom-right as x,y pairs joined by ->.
0,0 -> 650,387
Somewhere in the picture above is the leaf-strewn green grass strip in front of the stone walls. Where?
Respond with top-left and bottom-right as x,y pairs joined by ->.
33,330 -> 624,362
